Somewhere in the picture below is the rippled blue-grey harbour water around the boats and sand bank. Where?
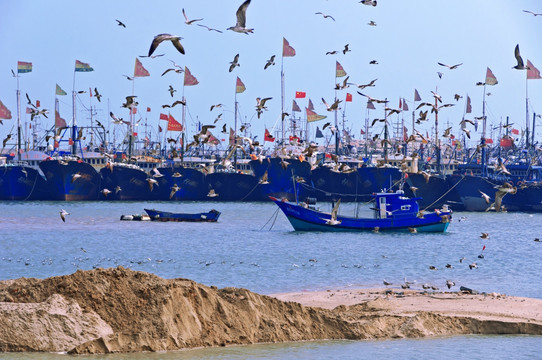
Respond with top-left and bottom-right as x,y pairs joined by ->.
0,202 -> 542,359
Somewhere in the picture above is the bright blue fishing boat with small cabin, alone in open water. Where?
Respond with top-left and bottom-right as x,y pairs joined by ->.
270,190 -> 452,232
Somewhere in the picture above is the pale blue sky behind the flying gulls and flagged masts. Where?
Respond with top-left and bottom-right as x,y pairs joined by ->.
0,0 -> 542,150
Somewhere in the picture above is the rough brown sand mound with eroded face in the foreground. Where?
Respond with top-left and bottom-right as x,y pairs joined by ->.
0,267 -> 542,354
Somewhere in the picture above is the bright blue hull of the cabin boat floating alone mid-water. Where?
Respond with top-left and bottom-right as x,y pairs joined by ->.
272,198 -> 451,232
